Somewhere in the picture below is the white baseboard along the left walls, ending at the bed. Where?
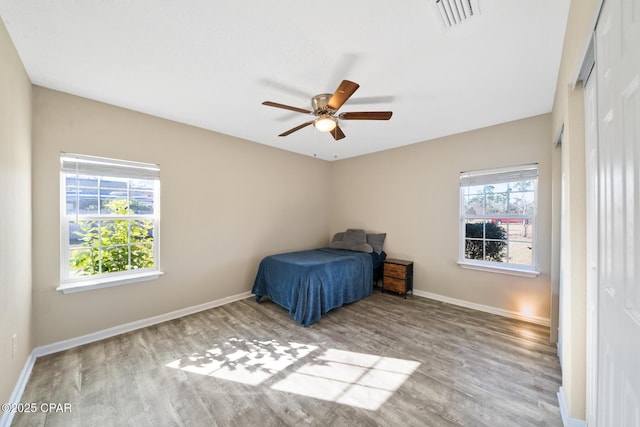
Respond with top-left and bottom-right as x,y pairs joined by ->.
0,291 -> 252,427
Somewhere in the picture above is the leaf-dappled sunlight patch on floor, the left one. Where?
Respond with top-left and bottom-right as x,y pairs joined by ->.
166,338 -> 317,386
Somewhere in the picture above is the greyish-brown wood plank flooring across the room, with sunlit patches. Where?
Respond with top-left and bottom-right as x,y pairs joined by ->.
12,292 -> 562,427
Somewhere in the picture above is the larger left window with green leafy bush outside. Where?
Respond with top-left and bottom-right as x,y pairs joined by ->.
58,153 -> 161,293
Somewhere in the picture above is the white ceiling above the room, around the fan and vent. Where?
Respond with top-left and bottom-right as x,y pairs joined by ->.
0,0 -> 570,160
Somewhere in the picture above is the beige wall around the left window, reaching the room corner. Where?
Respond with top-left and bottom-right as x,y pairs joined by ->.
33,87 -> 331,346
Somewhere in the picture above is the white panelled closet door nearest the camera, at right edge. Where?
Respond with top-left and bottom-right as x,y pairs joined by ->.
596,0 -> 640,427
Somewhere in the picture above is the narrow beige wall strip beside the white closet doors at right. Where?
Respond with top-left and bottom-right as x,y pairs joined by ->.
550,0 -> 601,420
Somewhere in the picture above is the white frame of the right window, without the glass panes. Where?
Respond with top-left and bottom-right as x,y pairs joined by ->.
458,164 -> 540,277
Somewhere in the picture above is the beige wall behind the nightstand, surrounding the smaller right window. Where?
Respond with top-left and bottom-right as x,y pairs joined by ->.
330,115 -> 551,319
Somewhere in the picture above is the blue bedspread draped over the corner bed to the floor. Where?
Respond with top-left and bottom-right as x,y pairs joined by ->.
251,248 -> 373,326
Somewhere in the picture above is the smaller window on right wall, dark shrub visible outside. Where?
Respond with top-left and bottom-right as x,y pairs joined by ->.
459,165 -> 538,277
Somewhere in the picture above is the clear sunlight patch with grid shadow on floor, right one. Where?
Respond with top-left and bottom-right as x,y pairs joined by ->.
272,349 -> 420,411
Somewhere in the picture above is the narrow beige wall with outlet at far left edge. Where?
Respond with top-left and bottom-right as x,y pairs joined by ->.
0,20 -> 33,404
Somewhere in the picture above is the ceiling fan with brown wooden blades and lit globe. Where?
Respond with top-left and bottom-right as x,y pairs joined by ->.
262,80 -> 393,141
